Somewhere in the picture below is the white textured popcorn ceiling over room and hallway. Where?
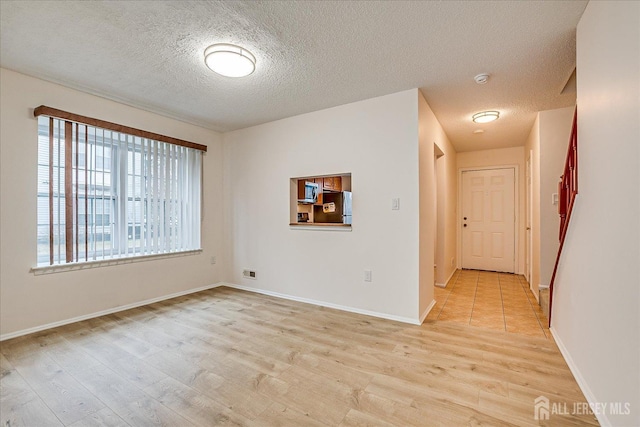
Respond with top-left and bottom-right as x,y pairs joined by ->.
0,0 -> 587,151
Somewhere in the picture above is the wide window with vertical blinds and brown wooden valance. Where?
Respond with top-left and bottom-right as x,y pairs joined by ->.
36,107 -> 206,266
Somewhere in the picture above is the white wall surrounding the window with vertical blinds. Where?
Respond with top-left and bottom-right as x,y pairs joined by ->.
0,69 -> 222,336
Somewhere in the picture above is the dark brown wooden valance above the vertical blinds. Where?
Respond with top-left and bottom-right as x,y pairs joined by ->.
33,105 -> 207,152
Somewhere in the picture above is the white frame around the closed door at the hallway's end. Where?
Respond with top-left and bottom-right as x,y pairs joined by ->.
456,164 -> 522,274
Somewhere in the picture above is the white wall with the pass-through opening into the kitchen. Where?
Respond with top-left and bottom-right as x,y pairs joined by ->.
224,89 -> 422,322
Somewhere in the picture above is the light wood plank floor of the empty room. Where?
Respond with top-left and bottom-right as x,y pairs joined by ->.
0,288 -> 596,427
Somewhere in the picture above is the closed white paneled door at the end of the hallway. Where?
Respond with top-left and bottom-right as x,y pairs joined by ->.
462,168 -> 515,273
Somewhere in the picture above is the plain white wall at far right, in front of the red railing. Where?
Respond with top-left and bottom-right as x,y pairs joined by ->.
552,1 -> 640,426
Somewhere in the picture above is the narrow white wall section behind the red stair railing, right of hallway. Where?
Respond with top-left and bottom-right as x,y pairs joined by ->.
534,106 -> 575,288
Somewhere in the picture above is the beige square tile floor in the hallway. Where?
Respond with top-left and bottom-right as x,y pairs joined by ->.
426,270 -> 551,338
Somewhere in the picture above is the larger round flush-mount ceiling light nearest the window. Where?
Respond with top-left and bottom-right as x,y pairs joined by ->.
204,43 -> 256,77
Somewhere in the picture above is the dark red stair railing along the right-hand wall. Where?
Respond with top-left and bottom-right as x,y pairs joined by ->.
549,107 -> 578,327
